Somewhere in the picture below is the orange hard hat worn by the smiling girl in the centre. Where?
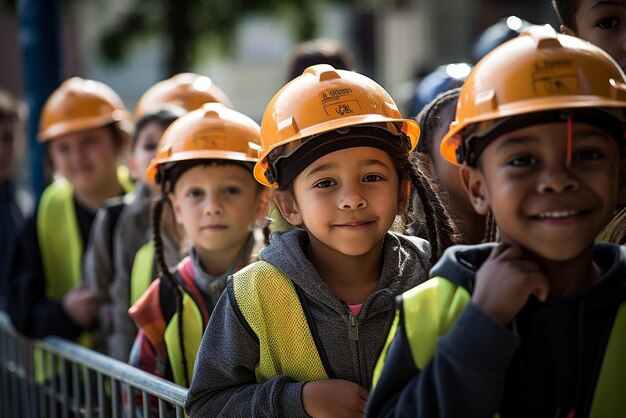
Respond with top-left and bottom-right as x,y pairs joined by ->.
254,64 -> 420,188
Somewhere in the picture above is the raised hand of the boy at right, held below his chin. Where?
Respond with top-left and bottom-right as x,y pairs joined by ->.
472,242 -> 549,325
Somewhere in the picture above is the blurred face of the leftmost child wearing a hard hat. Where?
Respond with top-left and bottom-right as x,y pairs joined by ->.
49,127 -> 121,192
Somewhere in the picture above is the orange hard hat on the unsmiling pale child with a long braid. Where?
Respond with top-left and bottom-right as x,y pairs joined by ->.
146,103 -> 261,183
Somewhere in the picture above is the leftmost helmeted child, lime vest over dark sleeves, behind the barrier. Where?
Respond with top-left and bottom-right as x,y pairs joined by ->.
8,77 -> 132,377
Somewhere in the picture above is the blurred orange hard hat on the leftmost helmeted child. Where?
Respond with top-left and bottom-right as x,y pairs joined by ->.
37,77 -> 132,142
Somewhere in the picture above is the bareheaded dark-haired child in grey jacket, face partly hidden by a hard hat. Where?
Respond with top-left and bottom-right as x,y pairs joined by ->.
83,107 -> 184,361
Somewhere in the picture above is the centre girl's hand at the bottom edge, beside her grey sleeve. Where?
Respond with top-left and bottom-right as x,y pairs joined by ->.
302,379 -> 368,418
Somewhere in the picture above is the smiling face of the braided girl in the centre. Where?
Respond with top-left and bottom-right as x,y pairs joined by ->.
279,147 -> 406,256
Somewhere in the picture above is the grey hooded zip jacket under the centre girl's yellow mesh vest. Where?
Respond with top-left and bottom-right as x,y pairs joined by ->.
185,230 -> 430,417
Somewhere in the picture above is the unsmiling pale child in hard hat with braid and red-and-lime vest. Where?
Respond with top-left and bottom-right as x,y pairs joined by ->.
129,103 -> 267,387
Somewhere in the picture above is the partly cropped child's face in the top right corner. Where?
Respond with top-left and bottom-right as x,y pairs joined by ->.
563,0 -> 626,71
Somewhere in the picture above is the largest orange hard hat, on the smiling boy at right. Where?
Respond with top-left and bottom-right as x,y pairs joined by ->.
440,25 -> 626,164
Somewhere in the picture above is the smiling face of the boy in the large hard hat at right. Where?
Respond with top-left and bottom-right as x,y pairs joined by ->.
463,123 -> 620,261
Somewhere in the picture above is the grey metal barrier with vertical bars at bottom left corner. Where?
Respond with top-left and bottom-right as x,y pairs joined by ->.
0,311 -> 187,418
